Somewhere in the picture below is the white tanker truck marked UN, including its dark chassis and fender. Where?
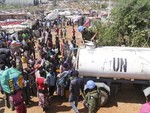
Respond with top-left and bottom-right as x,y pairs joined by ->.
75,43 -> 150,105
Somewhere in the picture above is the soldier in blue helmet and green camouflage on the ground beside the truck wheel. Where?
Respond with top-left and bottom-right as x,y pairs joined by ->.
84,80 -> 101,113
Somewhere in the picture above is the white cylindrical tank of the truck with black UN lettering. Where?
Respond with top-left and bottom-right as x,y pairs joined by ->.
76,46 -> 150,80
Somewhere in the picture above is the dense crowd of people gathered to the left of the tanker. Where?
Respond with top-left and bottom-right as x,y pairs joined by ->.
0,13 -> 102,113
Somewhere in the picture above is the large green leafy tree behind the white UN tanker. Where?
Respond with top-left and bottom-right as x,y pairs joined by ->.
94,0 -> 150,47
